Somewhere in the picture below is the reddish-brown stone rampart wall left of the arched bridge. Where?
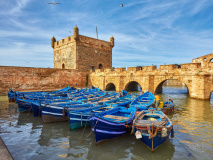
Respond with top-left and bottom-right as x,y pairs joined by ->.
0,66 -> 88,95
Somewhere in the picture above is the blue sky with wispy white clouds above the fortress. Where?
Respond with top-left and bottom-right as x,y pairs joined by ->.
0,0 -> 213,68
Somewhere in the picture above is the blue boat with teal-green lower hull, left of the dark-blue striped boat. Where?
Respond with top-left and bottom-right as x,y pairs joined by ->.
68,105 -> 113,130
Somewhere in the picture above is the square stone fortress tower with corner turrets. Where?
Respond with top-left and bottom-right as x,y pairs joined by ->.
51,26 -> 114,72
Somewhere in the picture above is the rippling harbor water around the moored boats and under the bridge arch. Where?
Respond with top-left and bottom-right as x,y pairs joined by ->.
0,86 -> 213,160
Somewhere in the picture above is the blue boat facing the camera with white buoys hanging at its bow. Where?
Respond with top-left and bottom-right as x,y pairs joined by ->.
132,110 -> 174,151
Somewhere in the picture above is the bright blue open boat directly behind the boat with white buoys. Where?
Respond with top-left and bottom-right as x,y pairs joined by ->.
130,91 -> 155,111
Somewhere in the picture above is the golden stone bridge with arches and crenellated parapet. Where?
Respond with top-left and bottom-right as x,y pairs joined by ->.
90,53 -> 213,100
